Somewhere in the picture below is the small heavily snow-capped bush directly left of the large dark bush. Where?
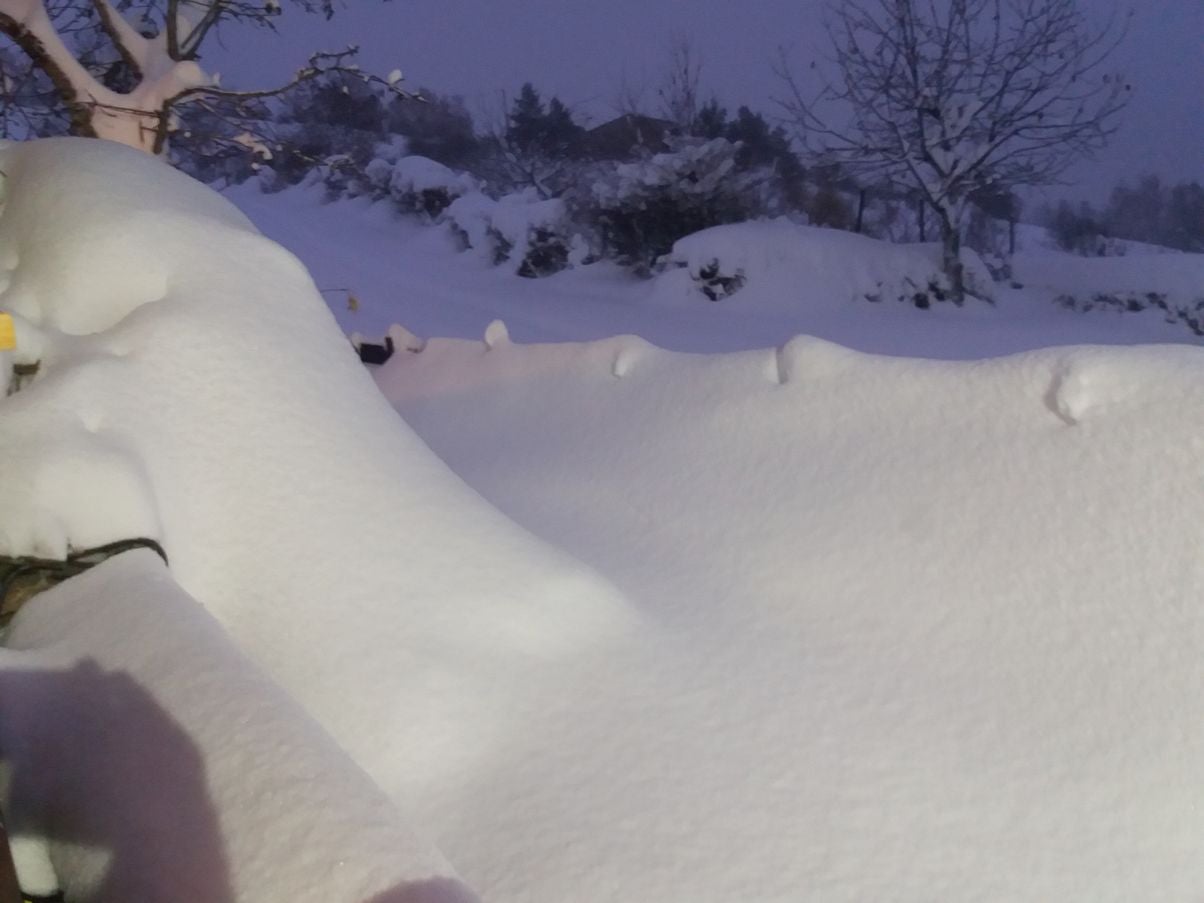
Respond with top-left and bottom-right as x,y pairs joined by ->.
443,190 -> 574,278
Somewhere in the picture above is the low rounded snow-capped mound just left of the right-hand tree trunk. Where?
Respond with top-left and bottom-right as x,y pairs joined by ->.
659,219 -> 993,308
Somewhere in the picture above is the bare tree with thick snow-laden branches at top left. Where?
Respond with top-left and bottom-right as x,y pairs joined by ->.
0,0 -> 404,154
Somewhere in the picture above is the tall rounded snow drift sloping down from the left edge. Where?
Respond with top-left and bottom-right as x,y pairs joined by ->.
0,138 -> 632,900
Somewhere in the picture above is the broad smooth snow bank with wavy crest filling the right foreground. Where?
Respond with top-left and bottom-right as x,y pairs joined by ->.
378,334 -> 1204,903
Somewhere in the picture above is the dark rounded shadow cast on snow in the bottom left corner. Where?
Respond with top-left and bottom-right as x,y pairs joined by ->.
0,661 -> 237,903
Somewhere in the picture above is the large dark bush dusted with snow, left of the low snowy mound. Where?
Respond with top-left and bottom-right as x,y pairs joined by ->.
573,138 -> 765,273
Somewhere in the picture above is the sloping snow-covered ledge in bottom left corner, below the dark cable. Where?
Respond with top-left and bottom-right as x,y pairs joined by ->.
0,551 -> 474,903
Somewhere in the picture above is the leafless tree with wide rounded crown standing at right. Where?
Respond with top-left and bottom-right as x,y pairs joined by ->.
778,0 -> 1129,303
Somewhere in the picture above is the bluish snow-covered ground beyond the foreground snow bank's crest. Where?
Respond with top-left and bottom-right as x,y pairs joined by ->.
228,178 -> 1204,359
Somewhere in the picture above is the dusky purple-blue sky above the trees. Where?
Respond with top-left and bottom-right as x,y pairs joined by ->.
206,0 -> 1204,201
